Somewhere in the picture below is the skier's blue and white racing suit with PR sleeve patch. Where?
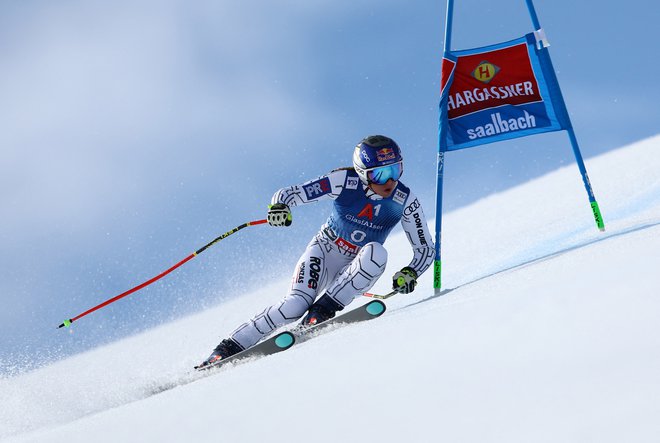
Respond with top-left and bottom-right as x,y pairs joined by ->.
231,168 -> 434,349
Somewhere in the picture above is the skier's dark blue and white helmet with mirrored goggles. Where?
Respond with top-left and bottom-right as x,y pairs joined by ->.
353,135 -> 403,185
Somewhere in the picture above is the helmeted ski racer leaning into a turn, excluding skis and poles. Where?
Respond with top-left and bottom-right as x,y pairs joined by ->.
199,135 -> 434,367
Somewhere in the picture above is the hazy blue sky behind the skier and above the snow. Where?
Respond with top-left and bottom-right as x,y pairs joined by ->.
0,0 -> 660,370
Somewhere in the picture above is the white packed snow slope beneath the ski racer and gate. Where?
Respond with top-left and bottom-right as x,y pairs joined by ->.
0,137 -> 660,443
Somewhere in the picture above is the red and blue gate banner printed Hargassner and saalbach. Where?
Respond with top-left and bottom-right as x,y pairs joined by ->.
440,33 -> 571,151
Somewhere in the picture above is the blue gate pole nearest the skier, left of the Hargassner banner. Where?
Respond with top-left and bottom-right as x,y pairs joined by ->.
433,0 -> 454,295
